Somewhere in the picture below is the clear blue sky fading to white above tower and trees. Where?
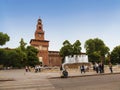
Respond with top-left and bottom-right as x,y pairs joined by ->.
0,0 -> 120,52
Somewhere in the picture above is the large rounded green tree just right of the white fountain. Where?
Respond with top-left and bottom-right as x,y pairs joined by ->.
84,38 -> 109,62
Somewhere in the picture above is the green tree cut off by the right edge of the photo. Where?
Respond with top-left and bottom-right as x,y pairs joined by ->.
110,45 -> 120,64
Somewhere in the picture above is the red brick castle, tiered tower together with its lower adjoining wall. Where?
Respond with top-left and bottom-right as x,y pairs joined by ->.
30,19 -> 62,66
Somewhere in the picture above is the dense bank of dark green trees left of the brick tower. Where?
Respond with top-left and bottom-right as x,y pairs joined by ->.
0,39 -> 39,68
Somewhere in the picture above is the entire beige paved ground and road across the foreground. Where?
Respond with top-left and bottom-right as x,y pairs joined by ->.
0,69 -> 120,90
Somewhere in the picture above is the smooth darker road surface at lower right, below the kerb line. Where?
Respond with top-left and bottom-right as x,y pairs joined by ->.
50,74 -> 120,90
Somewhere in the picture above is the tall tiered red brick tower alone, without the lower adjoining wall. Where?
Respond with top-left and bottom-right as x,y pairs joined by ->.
30,19 -> 49,66
